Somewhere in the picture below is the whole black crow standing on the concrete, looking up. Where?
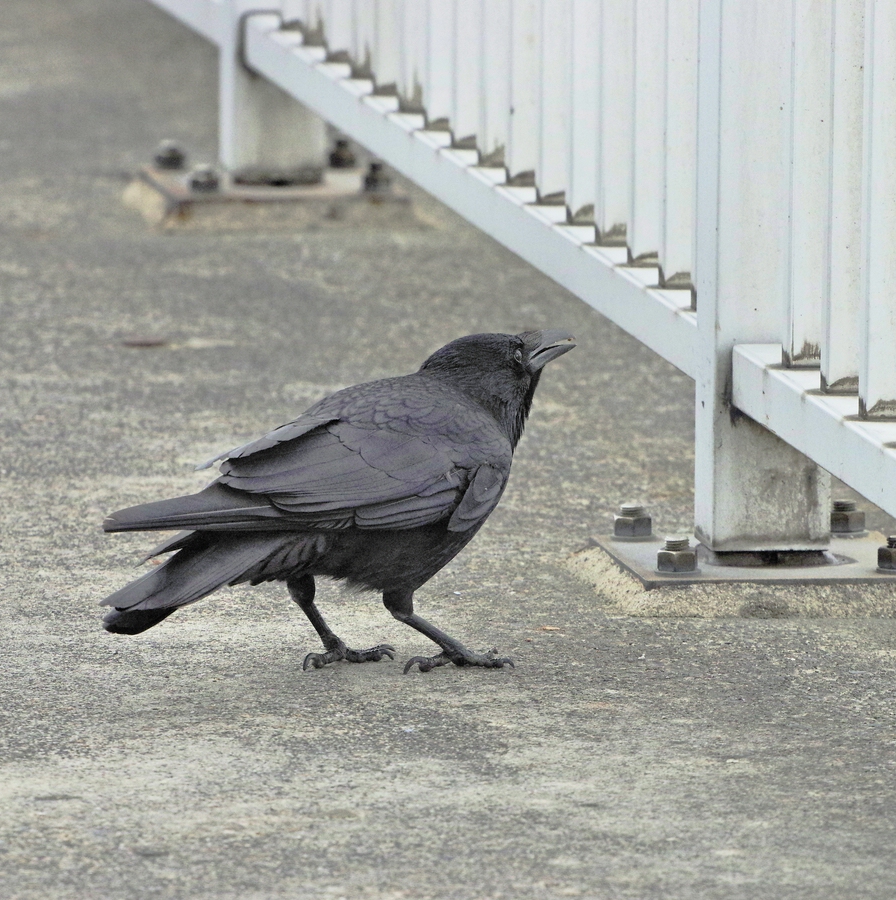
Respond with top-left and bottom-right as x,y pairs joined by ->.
102,331 -> 575,672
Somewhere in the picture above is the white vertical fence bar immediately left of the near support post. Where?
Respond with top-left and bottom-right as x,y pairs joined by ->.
660,0 -> 697,287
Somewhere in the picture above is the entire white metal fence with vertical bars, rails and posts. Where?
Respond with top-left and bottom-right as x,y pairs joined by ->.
140,0 -> 896,550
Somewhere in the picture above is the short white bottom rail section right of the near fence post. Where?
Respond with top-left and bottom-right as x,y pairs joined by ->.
732,344 -> 896,516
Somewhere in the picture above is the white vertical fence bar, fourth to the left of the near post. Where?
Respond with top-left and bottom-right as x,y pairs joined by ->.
566,0 -> 600,224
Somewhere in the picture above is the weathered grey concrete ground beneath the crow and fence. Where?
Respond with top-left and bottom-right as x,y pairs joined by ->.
0,0 -> 896,900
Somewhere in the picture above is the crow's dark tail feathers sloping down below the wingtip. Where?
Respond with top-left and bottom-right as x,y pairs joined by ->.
100,533 -> 283,634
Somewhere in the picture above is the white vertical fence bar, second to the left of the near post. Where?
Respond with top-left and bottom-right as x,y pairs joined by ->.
628,0 -> 666,260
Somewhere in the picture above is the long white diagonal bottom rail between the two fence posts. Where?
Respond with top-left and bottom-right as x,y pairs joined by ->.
240,17 -> 696,375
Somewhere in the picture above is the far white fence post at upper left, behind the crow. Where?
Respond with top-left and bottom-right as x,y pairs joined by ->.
218,0 -> 327,172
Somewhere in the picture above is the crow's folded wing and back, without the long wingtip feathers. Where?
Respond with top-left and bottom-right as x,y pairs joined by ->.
213,380 -> 512,531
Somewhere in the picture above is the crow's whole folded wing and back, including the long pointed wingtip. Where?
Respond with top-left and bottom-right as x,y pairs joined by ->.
103,376 -> 513,536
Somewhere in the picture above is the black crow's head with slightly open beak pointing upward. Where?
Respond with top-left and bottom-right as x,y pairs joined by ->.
420,329 -> 576,446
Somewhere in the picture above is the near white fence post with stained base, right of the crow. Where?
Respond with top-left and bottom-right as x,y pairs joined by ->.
695,0 -> 830,551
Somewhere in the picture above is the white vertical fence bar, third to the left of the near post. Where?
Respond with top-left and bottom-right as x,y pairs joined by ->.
595,0 -> 635,246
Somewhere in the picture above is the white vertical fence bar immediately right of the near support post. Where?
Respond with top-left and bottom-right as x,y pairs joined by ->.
781,0 -> 834,366
